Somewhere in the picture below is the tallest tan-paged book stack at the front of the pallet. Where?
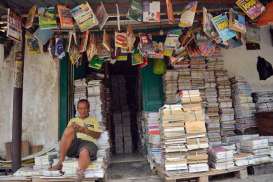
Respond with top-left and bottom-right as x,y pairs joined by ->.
180,90 -> 208,172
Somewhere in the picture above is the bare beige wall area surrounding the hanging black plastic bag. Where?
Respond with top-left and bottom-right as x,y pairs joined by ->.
222,27 -> 273,91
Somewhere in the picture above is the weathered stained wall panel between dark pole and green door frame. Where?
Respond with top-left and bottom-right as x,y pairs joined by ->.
23,50 -> 59,149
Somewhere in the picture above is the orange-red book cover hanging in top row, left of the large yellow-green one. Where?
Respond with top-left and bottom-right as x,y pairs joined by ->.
57,4 -> 74,29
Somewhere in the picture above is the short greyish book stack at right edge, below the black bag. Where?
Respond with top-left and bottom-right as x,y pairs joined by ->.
253,91 -> 273,113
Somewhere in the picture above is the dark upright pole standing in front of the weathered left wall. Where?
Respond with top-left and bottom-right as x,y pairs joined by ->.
11,31 -> 25,172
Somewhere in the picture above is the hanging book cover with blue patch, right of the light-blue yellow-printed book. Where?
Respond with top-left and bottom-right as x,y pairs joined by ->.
229,8 -> 246,34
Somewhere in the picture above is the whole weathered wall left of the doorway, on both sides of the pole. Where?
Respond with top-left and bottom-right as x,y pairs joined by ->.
0,45 -> 59,156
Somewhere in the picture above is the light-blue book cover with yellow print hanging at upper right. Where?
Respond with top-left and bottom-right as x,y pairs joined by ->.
211,14 -> 236,41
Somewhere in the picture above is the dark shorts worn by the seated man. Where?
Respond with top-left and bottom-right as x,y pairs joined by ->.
67,138 -> 98,161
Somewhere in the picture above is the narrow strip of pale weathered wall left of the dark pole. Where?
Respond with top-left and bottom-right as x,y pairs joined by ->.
0,44 -> 14,156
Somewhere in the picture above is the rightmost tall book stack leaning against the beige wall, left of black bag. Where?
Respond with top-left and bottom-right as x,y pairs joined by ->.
231,76 -> 256,133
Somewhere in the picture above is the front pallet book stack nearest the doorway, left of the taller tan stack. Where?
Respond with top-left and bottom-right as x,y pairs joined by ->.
160,104 -> 188,173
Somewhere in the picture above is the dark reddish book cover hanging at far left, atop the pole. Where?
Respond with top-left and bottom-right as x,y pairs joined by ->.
7,8 -> 22,41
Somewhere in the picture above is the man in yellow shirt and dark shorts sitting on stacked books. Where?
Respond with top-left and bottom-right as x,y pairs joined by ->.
51,99 -> 101,178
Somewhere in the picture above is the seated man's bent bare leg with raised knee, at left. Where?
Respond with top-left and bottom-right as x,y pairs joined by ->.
52,126 -> 75,170
